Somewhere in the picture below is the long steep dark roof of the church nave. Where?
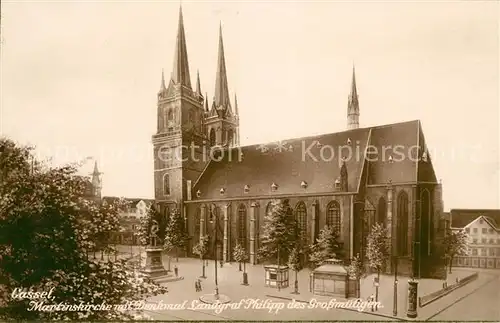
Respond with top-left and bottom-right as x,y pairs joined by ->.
193,120 -> 430,200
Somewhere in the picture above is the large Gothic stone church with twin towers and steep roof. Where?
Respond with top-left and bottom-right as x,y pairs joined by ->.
152,9 -> 444,277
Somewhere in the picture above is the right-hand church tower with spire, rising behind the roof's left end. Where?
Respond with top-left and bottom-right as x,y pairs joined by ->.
205,25 -> 240,147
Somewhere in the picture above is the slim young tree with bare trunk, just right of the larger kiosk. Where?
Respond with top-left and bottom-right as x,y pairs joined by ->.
366,223 -> 389,301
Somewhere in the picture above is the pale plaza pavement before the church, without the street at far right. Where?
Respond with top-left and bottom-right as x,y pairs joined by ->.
140,257 -> 487,320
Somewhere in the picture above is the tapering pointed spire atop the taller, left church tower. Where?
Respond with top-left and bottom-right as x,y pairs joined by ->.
172,6 -> 191,88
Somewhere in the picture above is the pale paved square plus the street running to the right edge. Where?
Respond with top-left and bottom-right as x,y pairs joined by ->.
130,257 -> 500,321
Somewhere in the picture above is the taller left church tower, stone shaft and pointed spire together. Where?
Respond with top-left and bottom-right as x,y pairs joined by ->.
152,7 -> 208,216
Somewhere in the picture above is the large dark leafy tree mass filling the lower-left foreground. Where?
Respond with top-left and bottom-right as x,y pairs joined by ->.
0,139 -> 166,320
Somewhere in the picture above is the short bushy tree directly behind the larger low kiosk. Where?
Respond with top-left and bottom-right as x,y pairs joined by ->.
309,226 -> 344,268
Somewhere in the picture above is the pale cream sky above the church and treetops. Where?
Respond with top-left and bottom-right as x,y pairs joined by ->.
0,1 -> 500,210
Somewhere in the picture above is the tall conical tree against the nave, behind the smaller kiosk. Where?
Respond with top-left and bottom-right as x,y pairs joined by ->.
258,199 -> 299,265
